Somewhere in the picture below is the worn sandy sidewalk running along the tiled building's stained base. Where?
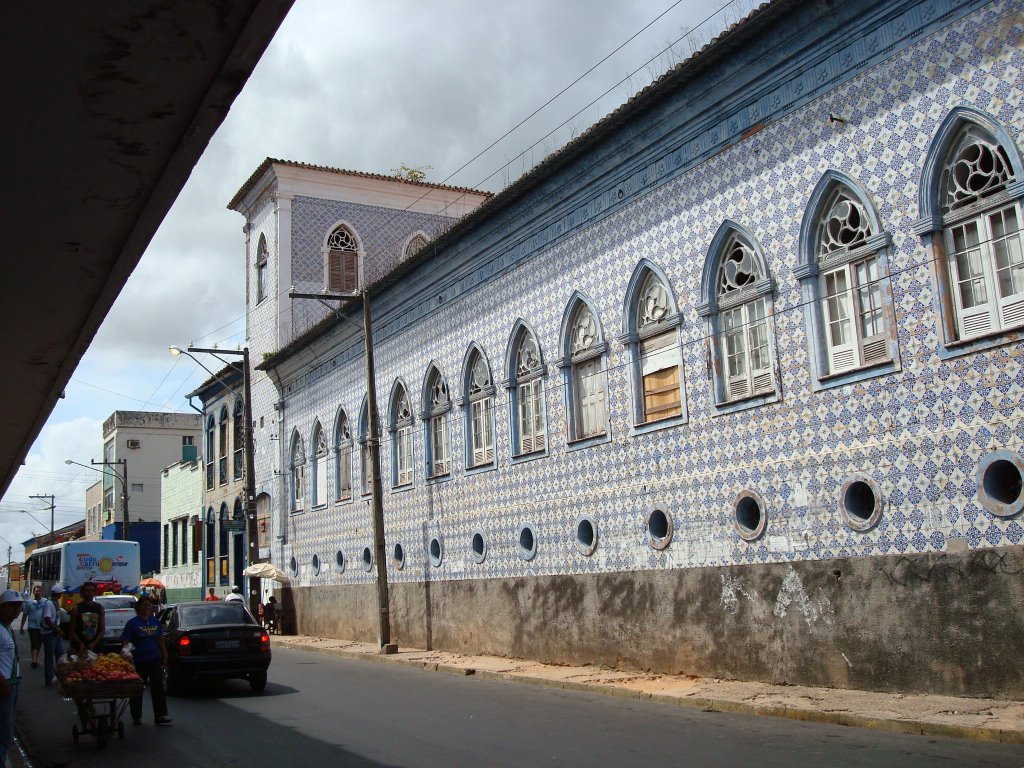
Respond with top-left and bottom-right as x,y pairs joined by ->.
271,635 -> 1024,744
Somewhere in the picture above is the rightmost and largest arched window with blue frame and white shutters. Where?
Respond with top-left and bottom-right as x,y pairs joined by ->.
912,106 -> 1024,359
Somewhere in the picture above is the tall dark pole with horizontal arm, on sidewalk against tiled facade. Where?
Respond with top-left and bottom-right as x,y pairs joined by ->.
288,289 -> 398,653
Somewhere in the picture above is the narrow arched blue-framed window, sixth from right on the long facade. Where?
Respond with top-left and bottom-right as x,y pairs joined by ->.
503,317 -> 548,462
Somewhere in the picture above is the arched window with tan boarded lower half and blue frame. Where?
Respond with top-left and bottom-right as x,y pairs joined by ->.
618,259 -> 686,434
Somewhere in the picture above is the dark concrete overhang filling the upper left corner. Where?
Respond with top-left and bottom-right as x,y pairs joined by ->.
0,0 -> 292,495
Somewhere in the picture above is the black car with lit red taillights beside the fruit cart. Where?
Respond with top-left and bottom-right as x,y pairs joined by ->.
160,600 -> 270,693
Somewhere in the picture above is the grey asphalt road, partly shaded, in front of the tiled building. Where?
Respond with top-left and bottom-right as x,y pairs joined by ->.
19,649 -> 1024,768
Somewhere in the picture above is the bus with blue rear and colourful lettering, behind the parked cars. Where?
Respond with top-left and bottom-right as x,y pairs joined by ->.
25,540 -> 141,607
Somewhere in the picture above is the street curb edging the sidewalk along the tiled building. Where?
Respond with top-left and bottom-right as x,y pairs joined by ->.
274,637 -> 1024,744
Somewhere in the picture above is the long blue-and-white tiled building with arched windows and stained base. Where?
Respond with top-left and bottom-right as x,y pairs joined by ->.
232,0 -> 1024,693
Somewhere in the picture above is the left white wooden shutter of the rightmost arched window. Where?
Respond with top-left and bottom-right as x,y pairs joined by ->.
946,219 -> 995,339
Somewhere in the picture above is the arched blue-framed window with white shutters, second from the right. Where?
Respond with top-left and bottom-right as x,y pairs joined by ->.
793,170 -> 899,390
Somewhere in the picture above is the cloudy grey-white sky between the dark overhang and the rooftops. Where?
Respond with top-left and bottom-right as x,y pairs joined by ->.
0,0 -> 753,559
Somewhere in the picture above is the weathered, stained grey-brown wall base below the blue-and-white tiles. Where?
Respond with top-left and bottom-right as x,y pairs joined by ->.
286,547 -> 1024,697
